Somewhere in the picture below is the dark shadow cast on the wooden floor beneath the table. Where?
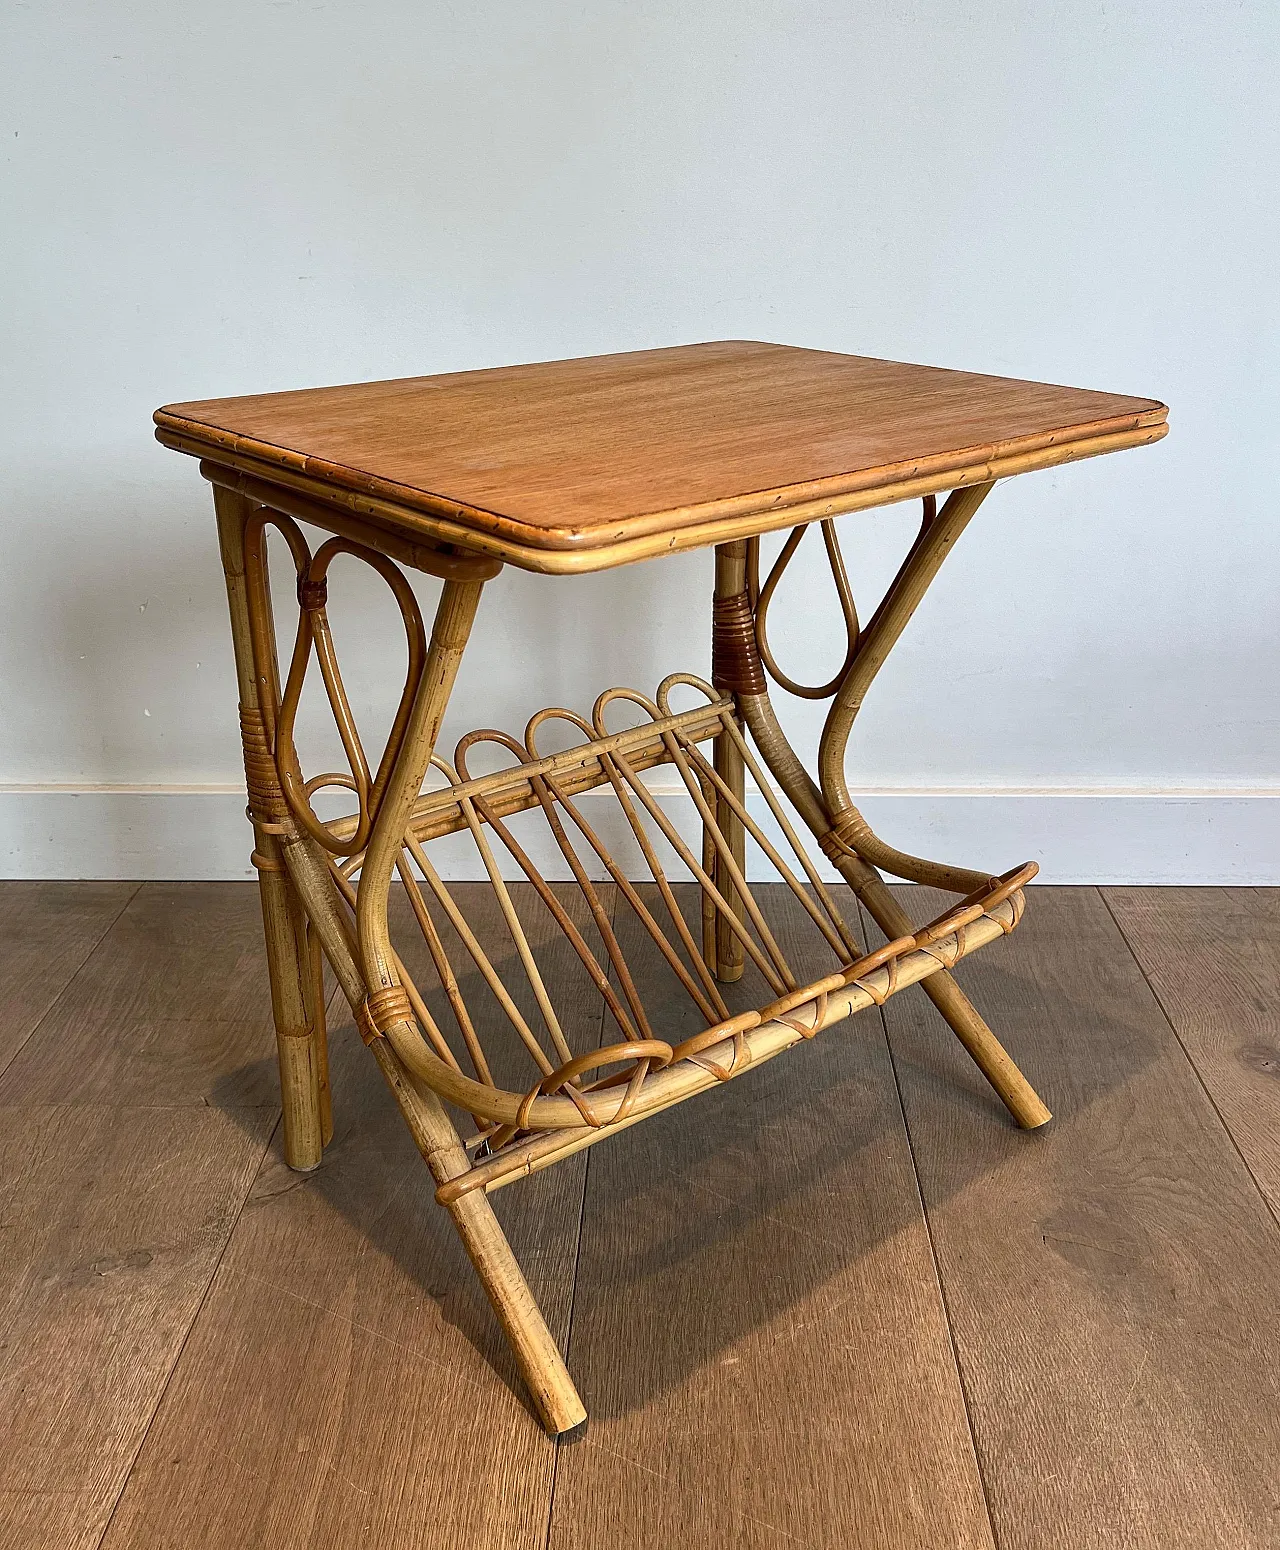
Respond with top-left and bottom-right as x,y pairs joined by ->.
201,890 -> 1154,1417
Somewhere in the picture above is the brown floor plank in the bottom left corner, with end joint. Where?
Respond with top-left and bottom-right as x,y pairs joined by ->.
0,1104 -> 274,1550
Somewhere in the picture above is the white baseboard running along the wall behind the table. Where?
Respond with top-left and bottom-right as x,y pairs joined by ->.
0,786 -> 1280,885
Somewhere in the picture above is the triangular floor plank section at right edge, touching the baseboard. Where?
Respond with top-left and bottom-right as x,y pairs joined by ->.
1103,888 -> 1280,1215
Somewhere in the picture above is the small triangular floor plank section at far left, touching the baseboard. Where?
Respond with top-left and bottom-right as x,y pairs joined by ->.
0,882 -> 138,1071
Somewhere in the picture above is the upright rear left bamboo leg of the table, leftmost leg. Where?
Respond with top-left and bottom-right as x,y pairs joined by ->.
214,485 -> 332,1172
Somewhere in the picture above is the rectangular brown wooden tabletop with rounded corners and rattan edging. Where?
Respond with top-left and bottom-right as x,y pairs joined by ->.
155,339 -> 1168,572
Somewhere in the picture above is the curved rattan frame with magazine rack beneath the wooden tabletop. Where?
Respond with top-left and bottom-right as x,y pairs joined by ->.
207,461 -> 1048,1432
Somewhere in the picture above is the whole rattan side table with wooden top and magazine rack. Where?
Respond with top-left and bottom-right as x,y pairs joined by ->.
155,341 -> 1167,1432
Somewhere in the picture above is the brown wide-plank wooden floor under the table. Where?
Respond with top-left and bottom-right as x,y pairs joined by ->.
0,884 -> 1280,1550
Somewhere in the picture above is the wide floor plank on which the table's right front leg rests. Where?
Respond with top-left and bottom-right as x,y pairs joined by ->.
885,888 -> 1280,1550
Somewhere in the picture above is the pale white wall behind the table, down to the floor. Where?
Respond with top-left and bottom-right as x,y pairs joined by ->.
0,0 -> 1280,882
